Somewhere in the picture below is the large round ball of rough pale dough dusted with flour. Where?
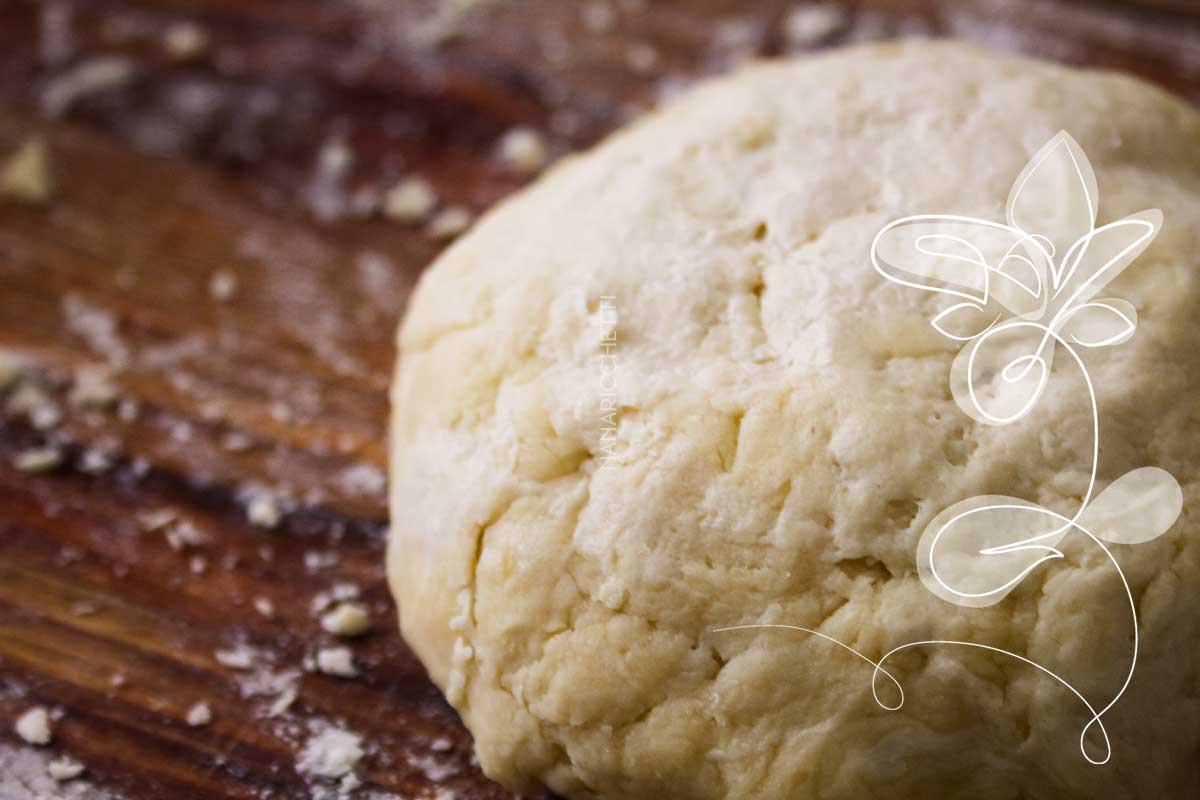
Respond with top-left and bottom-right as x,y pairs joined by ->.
388,43 -> 1200,800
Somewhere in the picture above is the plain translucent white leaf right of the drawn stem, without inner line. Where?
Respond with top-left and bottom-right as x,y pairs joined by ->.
1079,467 -> 1183,545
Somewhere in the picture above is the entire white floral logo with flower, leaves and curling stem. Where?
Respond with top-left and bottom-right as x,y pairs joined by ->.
722,131 -> 1183,764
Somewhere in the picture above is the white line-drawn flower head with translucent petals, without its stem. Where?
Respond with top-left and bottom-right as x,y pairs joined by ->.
871,131 -> 1163,425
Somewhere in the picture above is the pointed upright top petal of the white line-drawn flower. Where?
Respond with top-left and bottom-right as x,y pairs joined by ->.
1006,131 -> 1100,271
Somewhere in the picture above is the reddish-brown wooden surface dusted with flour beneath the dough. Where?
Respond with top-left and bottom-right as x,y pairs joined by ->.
0,0 -> 1200,800
